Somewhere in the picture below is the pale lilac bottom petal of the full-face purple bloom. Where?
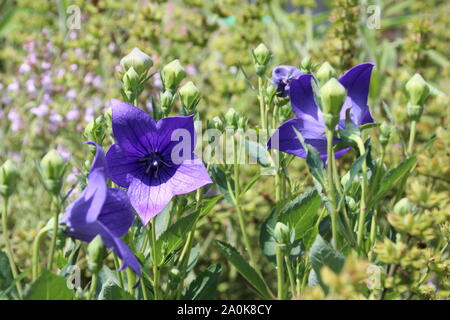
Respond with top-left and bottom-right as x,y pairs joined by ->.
128,171 -> 173,225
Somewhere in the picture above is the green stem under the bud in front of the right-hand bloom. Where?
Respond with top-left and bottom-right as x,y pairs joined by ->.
326,129 -> 341,250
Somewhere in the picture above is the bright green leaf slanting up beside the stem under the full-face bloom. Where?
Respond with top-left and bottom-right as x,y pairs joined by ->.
156,212 -> 198,266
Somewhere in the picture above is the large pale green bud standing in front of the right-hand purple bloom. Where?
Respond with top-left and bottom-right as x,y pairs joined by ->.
320,78 -> 347,129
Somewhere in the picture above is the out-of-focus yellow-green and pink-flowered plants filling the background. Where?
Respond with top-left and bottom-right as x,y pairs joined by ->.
0,0 -> 450,298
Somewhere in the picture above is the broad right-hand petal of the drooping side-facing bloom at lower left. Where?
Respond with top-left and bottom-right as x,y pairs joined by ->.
98,188 -> 134,237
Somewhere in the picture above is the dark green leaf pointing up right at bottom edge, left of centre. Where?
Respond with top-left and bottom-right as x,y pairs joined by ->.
183,264 -> 222,300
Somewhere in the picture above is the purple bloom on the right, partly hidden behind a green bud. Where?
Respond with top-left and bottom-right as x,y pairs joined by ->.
267,62 -> 374,161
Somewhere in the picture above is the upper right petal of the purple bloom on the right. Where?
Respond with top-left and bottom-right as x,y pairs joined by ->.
339,62 -> 375,126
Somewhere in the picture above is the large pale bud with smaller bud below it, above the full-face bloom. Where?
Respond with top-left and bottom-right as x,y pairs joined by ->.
120,48 -> 153,102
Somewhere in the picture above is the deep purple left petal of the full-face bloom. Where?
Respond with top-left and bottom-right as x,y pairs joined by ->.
106,144 -> 145,188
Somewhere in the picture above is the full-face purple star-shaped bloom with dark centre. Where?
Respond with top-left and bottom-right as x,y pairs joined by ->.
106,100 -> 212,225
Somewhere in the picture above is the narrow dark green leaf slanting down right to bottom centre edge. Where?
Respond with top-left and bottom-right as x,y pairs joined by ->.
216,240 -> 272,299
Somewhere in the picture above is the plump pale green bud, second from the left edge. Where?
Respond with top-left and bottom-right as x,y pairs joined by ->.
40,149 -> 66,195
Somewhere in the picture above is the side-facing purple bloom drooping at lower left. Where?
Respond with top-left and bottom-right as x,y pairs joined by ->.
61,142 -> 141,276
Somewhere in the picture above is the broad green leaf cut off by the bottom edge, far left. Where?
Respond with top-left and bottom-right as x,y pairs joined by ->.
25,270 -> 73,300
